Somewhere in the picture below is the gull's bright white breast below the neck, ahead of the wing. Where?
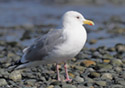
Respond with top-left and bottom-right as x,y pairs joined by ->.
58,26 -> 87,58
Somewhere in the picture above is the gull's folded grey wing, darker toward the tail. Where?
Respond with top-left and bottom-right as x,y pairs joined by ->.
24,30 -> 65,61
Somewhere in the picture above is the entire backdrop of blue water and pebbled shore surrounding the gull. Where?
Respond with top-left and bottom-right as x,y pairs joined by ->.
0,0 -> 125,88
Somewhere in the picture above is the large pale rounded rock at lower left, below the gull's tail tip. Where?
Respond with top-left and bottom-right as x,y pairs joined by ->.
9,71 -> 22,82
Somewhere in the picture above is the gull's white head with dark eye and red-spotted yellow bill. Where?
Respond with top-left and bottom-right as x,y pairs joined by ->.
63,11 -> 94,25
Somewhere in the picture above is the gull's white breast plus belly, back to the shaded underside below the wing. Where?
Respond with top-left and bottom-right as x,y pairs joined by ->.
45,26 -> 87,63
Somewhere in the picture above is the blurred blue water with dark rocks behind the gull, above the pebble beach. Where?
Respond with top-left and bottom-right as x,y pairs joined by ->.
0,0 -> 125,48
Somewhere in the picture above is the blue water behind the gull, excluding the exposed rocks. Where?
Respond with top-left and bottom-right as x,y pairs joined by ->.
0,1 -> 125,47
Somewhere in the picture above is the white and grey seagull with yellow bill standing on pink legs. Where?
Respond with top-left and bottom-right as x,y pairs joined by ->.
13,11 -> 94,81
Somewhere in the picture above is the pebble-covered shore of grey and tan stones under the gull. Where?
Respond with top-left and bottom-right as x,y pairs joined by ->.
0,38 -> 125,88
